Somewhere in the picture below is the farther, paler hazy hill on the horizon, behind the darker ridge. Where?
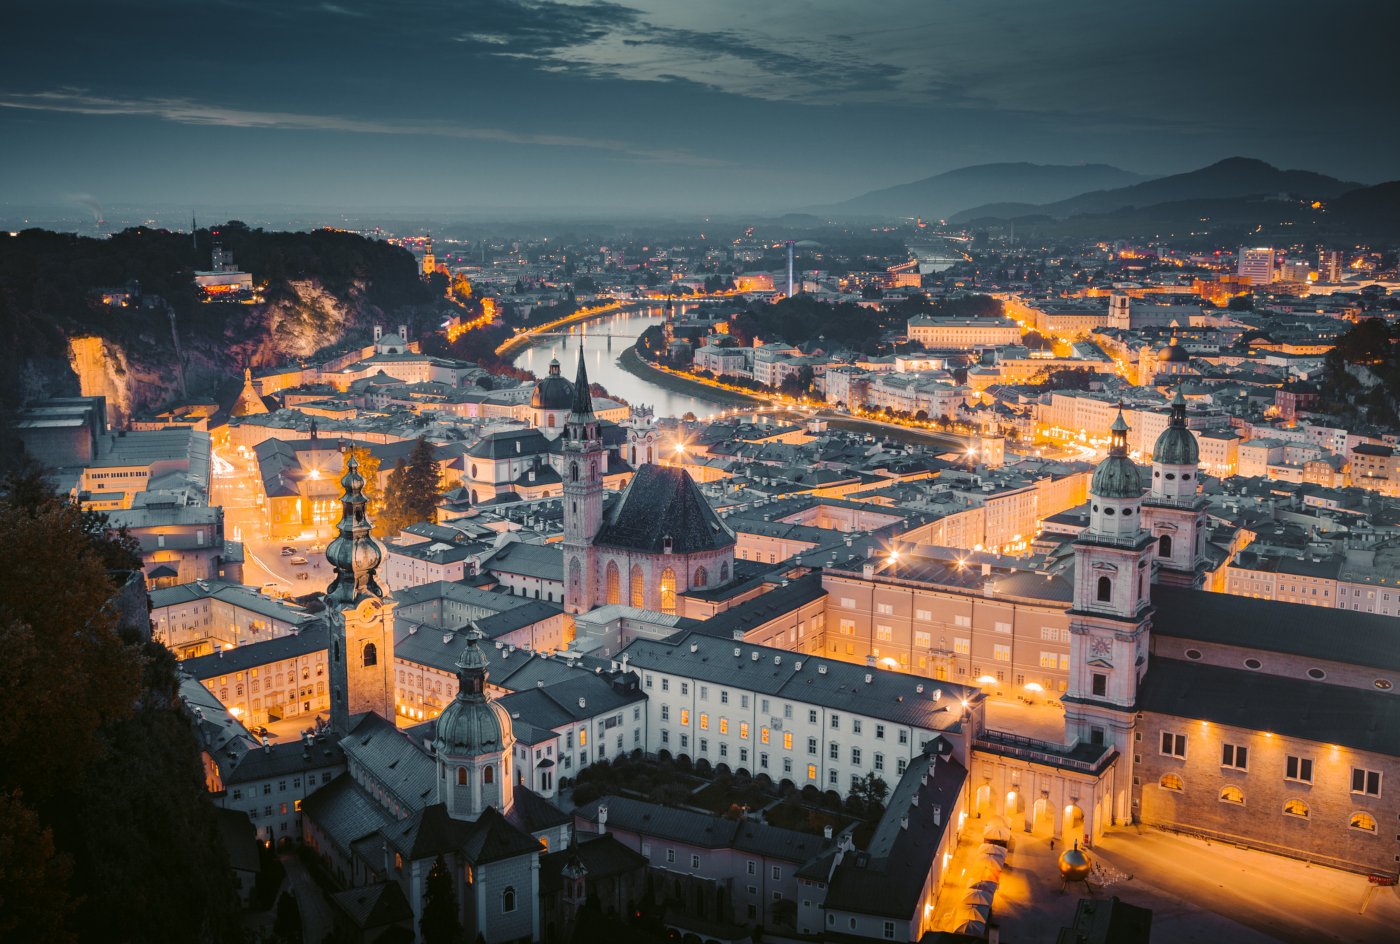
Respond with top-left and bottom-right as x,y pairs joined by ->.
813,162 -> 1145,220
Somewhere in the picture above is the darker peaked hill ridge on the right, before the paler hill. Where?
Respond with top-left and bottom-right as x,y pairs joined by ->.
951,157 -> 1361,223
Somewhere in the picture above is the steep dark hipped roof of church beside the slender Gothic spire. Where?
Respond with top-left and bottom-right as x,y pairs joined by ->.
594,464 -> 735,555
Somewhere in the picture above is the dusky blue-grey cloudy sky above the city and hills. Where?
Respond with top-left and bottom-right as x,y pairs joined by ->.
0,0 -> 1400,211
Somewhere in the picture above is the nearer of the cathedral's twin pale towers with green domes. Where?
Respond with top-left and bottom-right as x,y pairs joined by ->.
1061,409 -> 1152,819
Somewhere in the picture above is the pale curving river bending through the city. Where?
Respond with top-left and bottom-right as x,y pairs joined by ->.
515,305 -> 721,417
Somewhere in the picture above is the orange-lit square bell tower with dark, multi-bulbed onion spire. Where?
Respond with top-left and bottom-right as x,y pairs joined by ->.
325,452 -> 395,734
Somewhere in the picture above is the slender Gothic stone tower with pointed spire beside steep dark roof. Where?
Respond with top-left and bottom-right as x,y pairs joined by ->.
563,347 -> 608,613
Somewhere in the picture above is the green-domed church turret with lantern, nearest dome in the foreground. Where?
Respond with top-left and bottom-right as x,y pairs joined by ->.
433,623 -> 515,819
